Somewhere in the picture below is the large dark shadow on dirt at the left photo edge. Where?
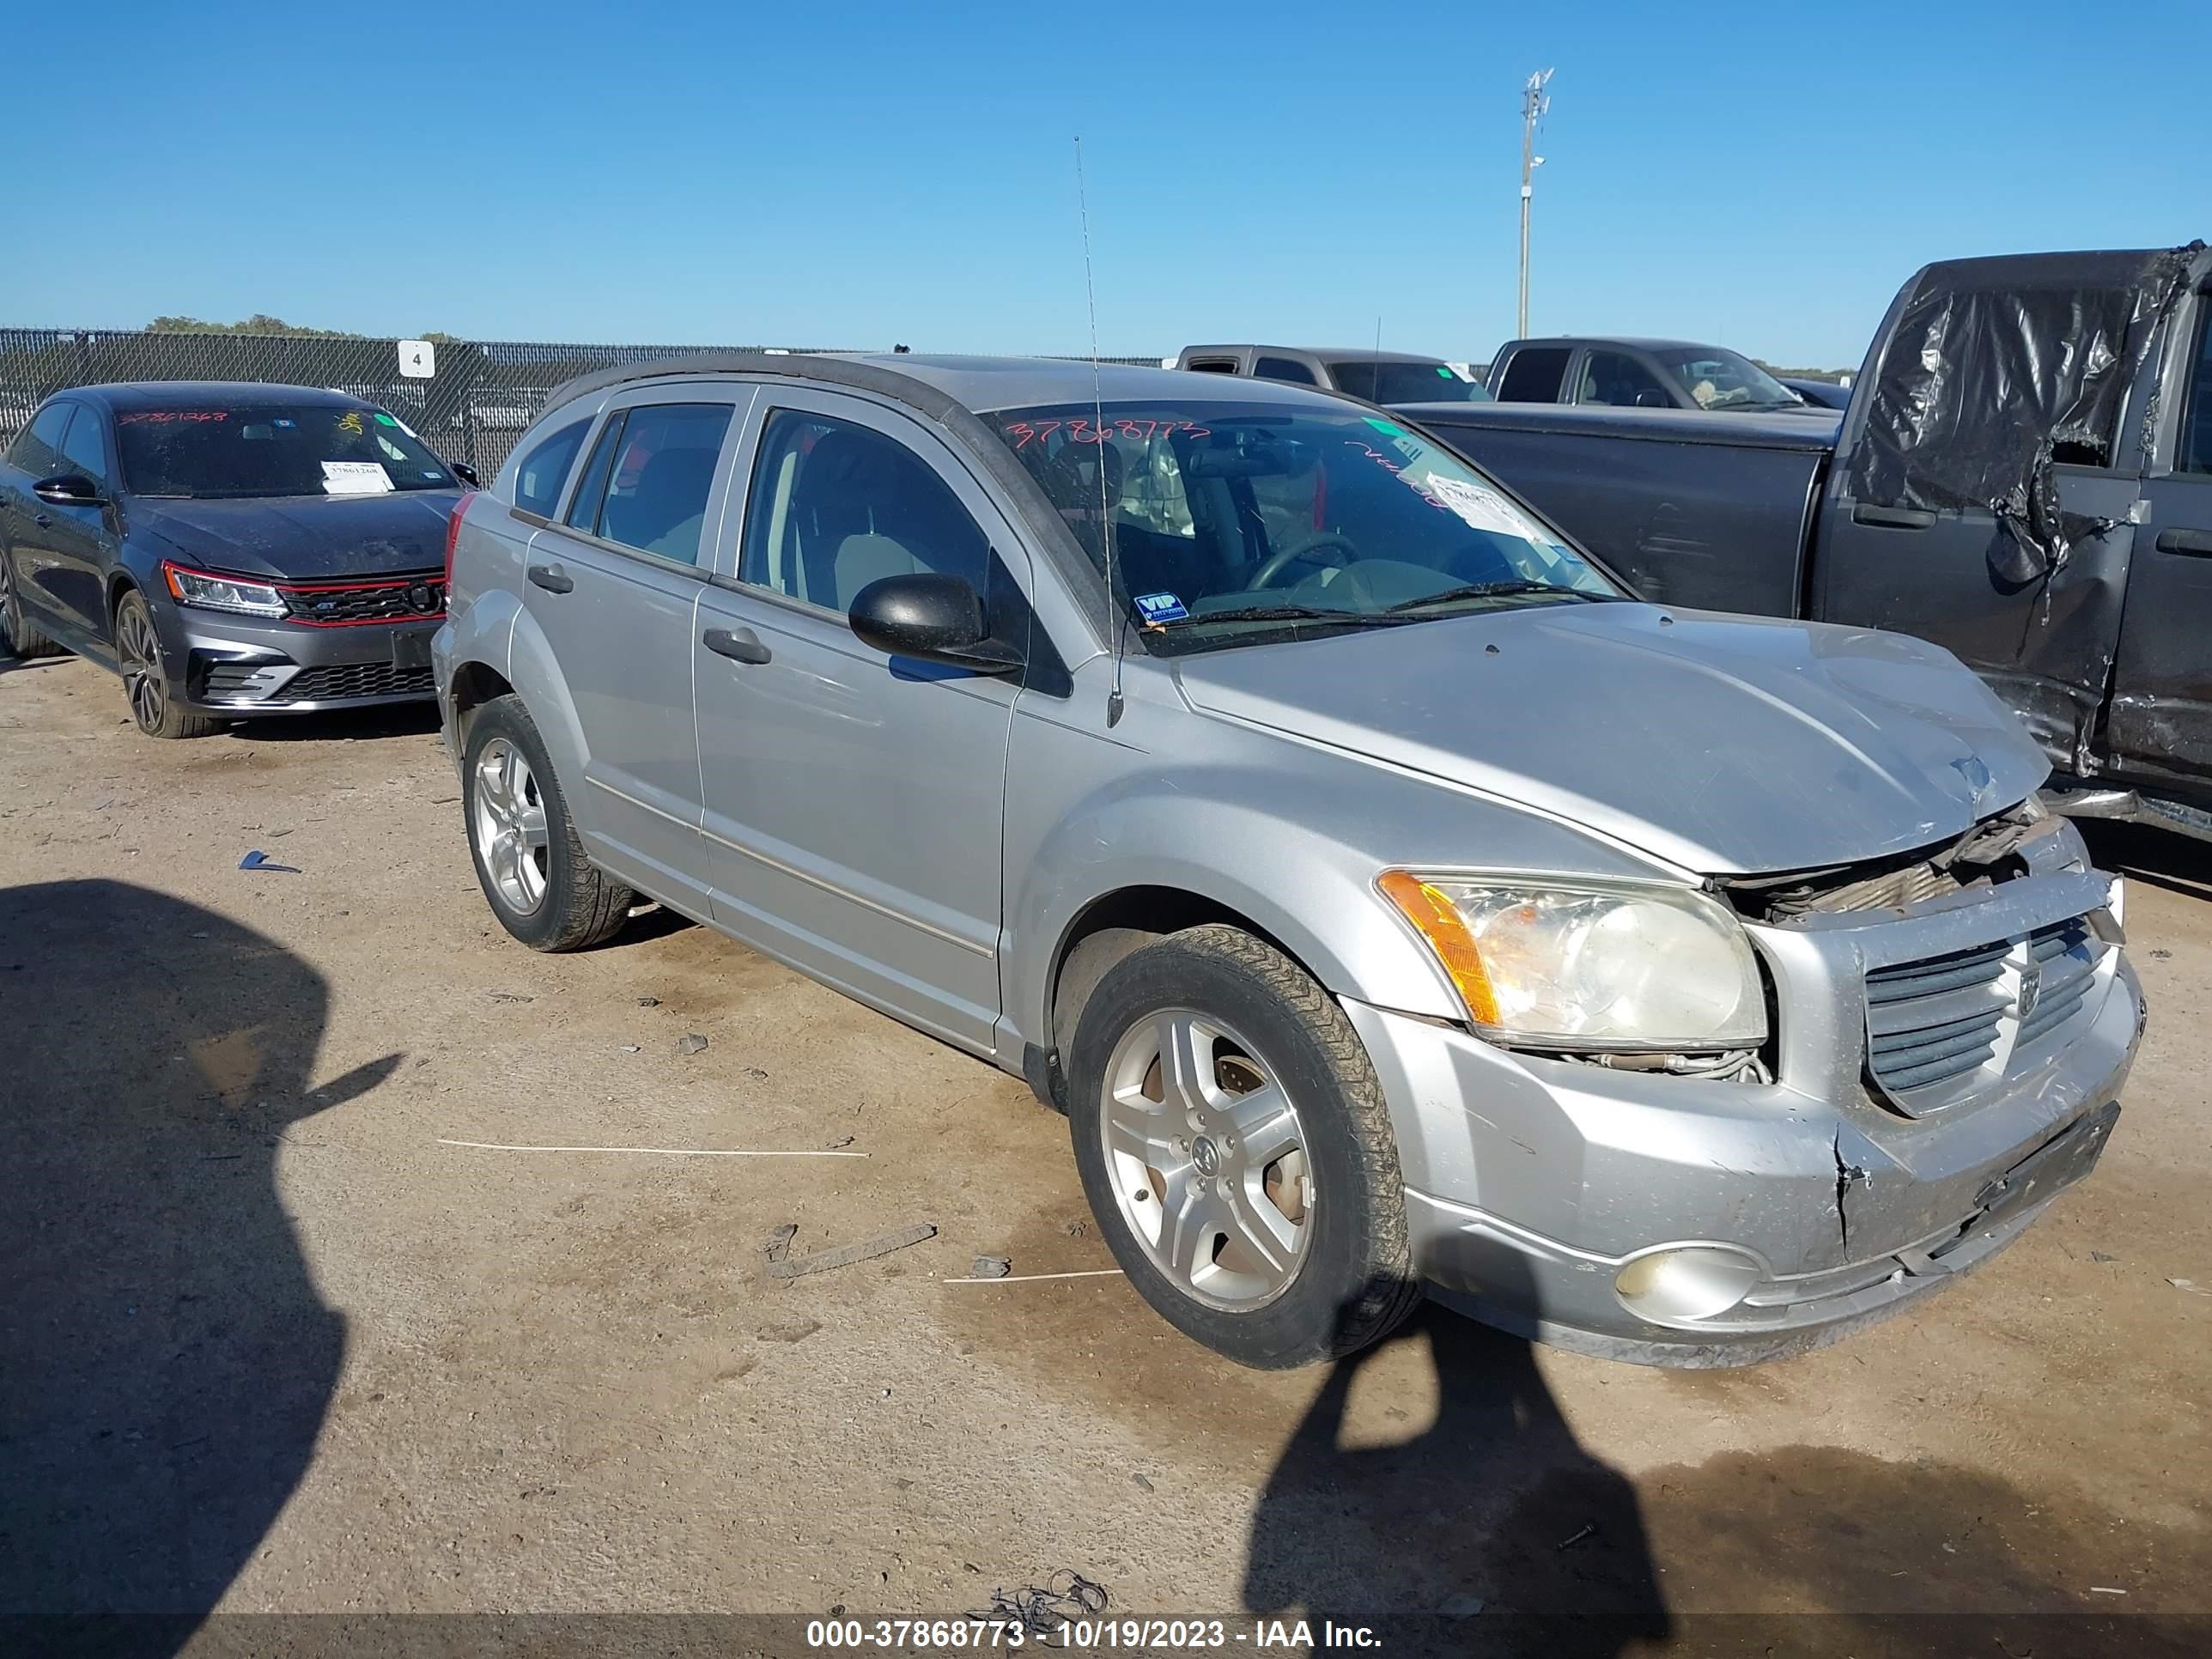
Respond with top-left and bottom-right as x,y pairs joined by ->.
0,880 -> 400,1655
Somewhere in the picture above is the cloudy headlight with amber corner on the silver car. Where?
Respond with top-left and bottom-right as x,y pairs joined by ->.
1376,869 -> 1767,1051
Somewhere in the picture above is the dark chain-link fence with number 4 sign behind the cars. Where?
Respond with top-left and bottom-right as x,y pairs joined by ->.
0,327 -> 1159,477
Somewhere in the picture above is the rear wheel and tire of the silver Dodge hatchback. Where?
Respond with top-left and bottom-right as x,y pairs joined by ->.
460,692 -> 635,951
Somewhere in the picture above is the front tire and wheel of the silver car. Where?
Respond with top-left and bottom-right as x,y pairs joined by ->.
1068,925 -> 1420,1370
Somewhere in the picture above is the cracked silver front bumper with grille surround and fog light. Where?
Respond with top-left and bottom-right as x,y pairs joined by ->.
1345,872 -> 2143,1367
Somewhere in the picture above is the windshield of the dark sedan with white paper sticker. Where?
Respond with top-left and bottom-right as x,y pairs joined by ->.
115,403 -> 453,498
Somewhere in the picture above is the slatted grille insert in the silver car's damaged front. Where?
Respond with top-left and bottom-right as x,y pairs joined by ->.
1867,918 -> 2106,1095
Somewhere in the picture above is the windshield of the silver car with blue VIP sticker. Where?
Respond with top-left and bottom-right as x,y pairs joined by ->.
1004,400 -> 1624,653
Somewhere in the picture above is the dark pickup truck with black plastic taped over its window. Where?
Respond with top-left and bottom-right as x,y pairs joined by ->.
1402,243 -> 2212,836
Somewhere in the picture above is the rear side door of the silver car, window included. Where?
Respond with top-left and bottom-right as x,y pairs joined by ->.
525,385 -> 752,915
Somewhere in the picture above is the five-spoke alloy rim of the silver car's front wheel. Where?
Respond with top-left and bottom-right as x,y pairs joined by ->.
1099,1009 -> 1314,1312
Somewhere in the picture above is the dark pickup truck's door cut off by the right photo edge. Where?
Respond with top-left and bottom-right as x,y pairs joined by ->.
2106,279 -> 2212,785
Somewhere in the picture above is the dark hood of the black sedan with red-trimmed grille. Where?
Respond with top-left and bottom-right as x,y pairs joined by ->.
128,489 -> 460,581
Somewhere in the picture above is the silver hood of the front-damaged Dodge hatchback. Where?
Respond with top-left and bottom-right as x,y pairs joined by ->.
1175,602 -> 2048,876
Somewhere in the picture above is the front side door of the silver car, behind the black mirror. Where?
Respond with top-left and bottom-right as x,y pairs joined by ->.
692,387 -> 1029,1053
